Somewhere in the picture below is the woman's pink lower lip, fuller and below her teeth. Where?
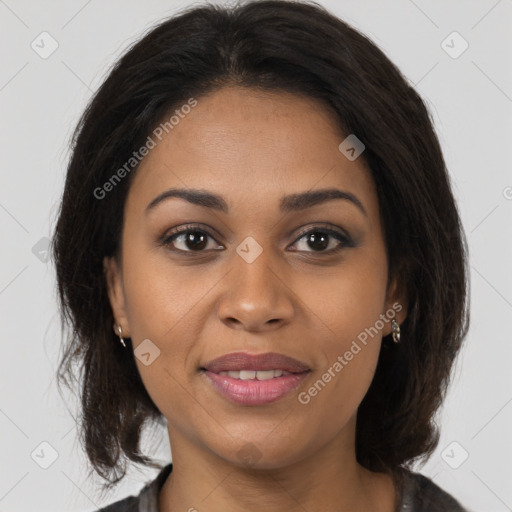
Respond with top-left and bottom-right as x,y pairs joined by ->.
204,370 -> 309,405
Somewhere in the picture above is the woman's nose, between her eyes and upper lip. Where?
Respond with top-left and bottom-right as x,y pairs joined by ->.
218,251 -> 296,332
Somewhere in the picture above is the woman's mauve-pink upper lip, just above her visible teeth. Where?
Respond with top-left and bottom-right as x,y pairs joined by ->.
203,352 -> 310,373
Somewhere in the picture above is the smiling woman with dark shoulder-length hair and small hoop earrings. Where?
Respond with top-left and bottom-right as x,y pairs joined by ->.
53,1 -> 468,512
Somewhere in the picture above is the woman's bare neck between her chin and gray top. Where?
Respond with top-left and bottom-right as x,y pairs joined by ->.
159,420 -> 396,512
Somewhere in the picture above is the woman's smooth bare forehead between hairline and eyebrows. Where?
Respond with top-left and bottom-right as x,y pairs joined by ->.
128,87 -> 377,220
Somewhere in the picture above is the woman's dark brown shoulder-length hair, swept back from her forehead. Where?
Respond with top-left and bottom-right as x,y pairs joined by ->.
52,0 -> 469,494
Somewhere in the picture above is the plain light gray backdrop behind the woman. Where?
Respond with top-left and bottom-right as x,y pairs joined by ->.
0,0 -> 512,512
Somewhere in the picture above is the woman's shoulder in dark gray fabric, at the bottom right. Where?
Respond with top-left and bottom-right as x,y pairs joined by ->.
400,471 -> 468,512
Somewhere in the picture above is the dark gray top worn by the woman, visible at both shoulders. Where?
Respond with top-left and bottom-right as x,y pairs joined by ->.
97,463 -> 468,512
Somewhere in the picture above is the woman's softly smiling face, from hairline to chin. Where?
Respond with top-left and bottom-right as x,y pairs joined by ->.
103,87 -> 405,468
